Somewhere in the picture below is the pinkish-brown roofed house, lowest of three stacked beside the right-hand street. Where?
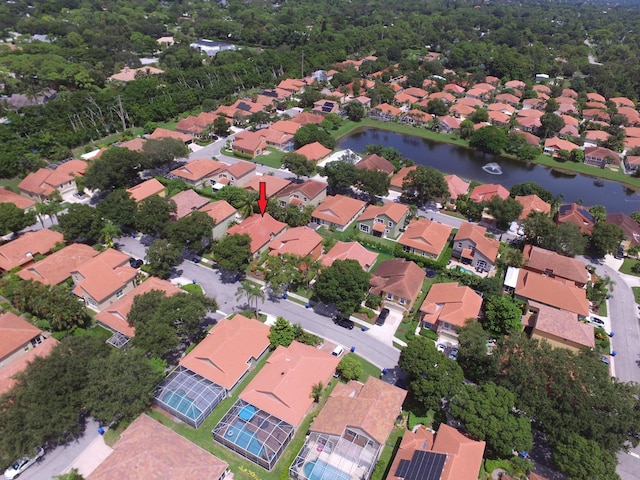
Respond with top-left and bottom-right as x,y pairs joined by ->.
522,300 -> 595,353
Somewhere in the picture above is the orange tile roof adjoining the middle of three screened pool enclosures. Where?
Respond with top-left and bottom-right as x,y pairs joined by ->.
240,341 -> 340,427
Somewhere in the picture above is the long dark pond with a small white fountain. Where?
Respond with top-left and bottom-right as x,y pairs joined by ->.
338,128 -> 640,213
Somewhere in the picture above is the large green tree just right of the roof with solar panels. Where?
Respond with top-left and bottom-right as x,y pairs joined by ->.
449,382 -> 533,458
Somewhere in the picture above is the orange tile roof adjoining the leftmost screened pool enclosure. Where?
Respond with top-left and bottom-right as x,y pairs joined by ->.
180,314 -> 269,392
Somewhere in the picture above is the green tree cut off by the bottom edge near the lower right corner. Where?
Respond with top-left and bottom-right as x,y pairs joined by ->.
553,434 -> 620,480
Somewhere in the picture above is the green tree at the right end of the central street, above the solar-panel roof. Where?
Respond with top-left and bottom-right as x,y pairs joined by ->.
398,336 -> 464,410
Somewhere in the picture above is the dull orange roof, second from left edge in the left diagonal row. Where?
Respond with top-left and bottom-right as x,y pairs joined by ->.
18,243 -> 99,285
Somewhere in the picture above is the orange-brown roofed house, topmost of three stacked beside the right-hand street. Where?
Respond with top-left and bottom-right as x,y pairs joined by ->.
522,245 -> 591,288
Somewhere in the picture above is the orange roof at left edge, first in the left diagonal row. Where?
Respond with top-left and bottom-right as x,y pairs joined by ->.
0,228 -> 64,272
